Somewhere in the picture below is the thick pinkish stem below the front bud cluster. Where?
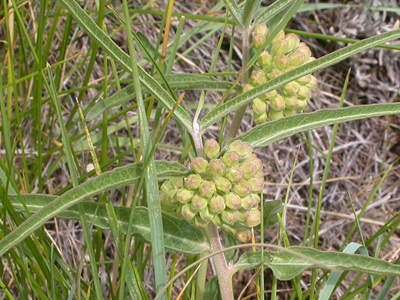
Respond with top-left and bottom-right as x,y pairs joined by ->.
204,224 -> 234,300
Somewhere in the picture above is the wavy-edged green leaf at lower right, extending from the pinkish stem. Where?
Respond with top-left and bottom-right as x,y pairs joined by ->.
235,247 -> 400,280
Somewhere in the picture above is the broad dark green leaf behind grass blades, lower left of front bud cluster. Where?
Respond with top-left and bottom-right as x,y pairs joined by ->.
4,195 -> 208,255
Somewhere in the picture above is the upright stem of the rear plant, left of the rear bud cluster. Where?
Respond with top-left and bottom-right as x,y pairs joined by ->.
227,28 -> 250,141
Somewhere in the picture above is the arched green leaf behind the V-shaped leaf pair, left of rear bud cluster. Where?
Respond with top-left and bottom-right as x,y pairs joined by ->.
86,74 -> 240,120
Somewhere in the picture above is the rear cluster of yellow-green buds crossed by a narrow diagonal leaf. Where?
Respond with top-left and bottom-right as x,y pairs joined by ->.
248,25 -> 317,124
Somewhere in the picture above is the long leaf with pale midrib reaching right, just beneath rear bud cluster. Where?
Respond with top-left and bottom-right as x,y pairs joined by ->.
223,103 -> 400,148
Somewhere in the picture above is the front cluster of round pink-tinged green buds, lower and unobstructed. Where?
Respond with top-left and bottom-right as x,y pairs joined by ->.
160,139 -> 264,242
